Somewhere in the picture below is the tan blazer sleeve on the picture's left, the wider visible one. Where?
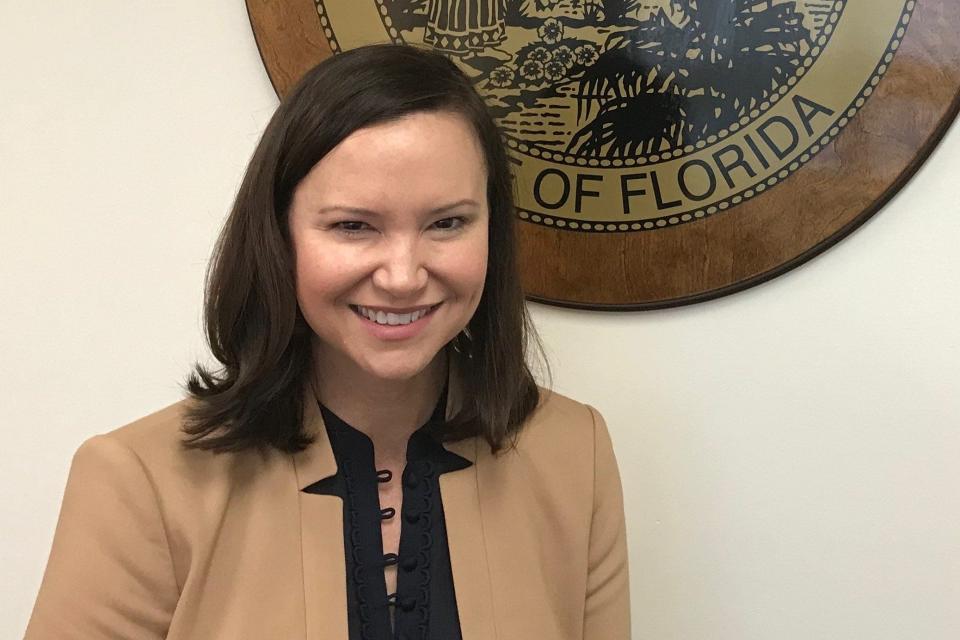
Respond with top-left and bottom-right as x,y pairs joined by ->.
25,435 -> 179,640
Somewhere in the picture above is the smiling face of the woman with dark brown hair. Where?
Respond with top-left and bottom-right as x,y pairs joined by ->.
289,112 -> 489,380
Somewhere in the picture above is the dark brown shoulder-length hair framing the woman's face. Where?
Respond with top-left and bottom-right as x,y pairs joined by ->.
184,45 -> 542,452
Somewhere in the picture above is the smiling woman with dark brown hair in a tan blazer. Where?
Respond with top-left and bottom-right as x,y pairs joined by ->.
26,45 -> 629,640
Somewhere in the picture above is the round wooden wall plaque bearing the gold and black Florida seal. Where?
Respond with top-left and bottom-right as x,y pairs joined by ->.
247,0 -> 960,310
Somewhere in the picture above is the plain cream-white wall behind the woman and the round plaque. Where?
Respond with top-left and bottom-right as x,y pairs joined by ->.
0,0 -> 960,640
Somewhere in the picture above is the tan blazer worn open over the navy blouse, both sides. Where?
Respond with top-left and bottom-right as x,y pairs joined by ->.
26,384 -> 630,640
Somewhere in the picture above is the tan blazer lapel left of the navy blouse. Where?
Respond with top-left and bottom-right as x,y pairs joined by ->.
293,390 -> 348,640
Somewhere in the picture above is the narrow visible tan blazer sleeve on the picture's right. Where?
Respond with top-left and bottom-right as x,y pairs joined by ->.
583,407 -> 630,640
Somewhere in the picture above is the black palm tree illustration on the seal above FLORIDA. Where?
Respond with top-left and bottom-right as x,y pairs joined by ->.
567,0 -> 811,157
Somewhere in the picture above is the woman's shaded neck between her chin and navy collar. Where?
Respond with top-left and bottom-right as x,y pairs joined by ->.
314,351 -> 447,459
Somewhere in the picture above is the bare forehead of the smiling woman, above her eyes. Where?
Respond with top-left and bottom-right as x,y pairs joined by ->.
297,112 -> 487,210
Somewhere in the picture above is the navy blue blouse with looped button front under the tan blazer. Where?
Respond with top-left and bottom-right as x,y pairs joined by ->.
304,393 -> 472,640
